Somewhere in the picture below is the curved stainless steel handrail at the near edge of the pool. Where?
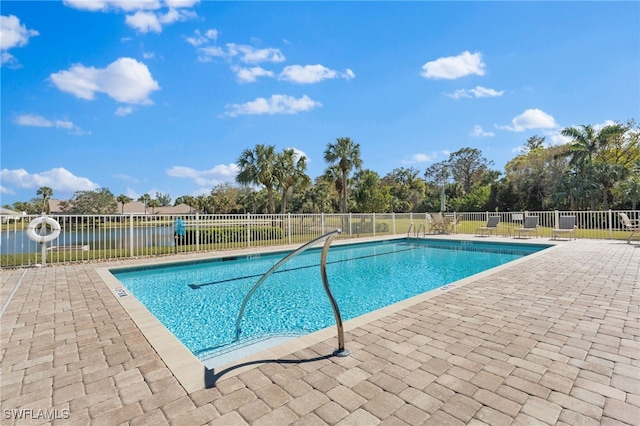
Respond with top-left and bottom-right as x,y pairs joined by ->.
234,229 -> 349,357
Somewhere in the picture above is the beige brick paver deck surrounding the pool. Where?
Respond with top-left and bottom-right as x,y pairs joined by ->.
0,238 -> 640,426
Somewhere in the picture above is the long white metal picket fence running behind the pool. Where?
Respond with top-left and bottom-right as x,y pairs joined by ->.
0,210 -> 640,268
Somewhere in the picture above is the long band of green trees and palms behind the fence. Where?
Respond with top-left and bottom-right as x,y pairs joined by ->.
5,120 -> 640,214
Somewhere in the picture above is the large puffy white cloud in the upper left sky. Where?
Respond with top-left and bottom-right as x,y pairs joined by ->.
50,58 -> 160,105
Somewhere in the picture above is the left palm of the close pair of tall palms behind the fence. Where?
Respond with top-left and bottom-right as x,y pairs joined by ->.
236,144 -> 278,213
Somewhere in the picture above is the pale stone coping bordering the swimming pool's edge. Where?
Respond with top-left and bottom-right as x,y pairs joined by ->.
95,235 -> 558,393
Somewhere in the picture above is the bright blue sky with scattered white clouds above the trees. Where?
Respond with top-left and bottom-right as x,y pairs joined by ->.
0,0 -> 640,205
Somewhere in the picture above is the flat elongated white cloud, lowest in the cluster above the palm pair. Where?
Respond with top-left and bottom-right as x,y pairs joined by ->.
225,95 -> 322,117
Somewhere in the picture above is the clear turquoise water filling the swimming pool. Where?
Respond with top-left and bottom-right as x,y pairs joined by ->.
111,239 -> 548,359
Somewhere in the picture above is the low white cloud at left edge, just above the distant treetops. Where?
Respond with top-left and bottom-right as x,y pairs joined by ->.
0,167 -> 100,192
